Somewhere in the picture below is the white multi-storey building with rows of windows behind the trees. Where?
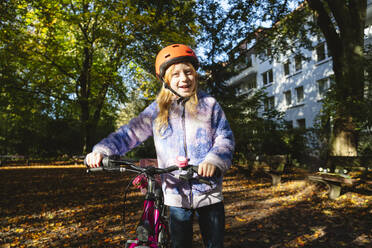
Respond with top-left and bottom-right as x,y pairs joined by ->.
227,0 -> 372,128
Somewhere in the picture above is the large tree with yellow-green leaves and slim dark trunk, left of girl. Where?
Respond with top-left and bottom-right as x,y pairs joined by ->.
0,0 -> 197,152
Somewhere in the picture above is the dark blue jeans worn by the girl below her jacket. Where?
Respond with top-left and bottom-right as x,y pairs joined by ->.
169,202 -> 225,248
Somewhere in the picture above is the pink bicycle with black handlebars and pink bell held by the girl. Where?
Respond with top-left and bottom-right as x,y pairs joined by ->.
88,156 -> 214,248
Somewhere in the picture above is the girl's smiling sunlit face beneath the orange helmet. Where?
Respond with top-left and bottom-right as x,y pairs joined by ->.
168,63 -> 196,97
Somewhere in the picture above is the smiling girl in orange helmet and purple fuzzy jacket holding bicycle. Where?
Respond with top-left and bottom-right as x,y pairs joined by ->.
86,44 -> 234,248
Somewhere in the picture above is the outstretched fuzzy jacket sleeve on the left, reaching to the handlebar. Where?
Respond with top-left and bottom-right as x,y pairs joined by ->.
93,102 -> 157,155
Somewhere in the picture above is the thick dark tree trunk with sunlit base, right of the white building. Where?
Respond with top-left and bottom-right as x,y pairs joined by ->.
307,0 -> 367,159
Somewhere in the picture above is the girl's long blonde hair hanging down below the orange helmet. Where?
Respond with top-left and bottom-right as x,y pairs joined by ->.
155,62 -> 198,134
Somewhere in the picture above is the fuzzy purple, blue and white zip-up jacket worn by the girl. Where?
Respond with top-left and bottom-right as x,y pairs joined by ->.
93,92 -> 235,209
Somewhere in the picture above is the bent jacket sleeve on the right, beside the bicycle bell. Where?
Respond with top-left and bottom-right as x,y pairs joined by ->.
204,102 -> 235,173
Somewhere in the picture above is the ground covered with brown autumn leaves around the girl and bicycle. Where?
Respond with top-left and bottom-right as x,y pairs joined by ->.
0,166 -> 372,248
